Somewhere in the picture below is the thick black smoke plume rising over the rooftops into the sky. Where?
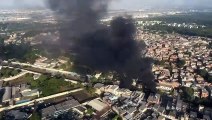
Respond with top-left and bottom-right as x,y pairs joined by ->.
49,0 -> 155,90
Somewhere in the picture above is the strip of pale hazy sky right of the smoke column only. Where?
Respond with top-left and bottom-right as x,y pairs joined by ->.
112,0 -> 212,9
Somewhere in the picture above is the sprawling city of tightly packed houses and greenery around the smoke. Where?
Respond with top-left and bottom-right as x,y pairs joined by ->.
0,4 -> 212,120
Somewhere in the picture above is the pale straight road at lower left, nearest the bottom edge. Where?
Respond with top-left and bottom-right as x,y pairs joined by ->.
0,88 -> 83,112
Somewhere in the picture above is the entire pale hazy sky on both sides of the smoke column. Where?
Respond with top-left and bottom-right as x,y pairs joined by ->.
0,0 -> 212,9
